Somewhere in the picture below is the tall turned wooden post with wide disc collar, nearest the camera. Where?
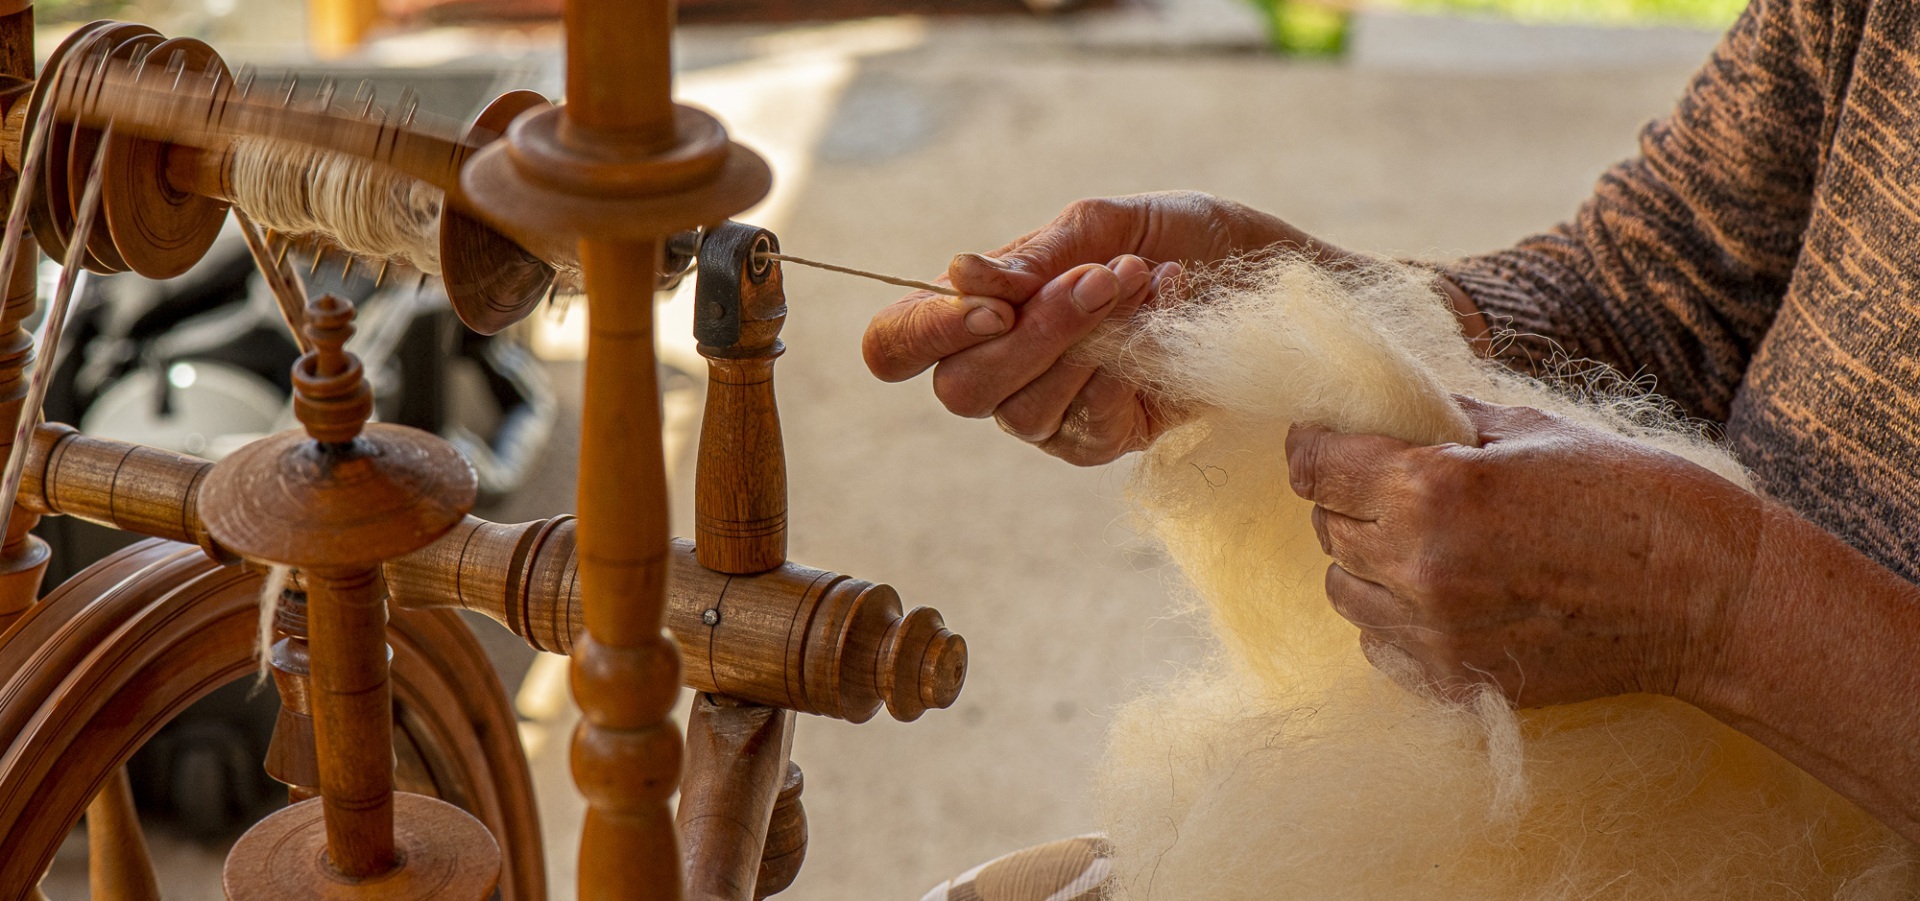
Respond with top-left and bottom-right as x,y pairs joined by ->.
461,0 -> 770,901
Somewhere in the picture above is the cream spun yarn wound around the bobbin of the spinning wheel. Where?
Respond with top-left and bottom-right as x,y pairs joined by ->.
227,138 -> 445,275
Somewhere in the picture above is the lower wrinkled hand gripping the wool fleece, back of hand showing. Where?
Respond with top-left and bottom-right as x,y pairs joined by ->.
1286,400 -> 1764,705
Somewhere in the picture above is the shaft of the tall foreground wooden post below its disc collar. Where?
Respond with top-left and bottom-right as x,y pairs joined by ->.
568,237 -> 682,901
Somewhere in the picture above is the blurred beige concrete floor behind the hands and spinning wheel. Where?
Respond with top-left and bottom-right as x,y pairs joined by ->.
33,7 -> 1711,901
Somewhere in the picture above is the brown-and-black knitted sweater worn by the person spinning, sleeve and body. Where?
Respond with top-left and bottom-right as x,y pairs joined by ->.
1442,0 -> 1920,582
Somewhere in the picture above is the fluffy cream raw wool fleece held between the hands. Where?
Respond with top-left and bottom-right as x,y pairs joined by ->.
1079,257 -> 1920,901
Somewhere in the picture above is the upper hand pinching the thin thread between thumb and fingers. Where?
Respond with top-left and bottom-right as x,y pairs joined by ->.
862,192 -> 1338,465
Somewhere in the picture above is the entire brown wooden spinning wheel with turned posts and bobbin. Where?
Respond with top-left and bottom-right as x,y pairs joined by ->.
0,0 -> 966,901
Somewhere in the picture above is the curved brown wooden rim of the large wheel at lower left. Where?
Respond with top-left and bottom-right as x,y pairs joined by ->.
0,540 -> 545,901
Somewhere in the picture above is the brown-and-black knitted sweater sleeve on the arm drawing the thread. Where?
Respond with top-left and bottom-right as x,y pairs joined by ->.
1440,0 -> 1845,421
